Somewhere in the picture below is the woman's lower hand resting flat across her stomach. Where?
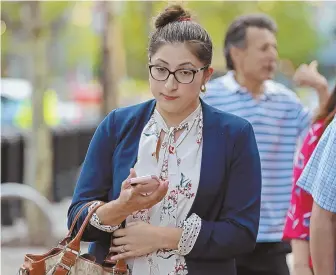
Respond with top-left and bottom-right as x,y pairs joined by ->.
111,222 -> 162,261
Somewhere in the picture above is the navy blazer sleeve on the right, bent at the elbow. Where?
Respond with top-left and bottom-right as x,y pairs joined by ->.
186,123 -> 261,260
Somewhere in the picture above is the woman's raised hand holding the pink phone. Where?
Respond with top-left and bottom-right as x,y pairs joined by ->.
118,168 -> 168,214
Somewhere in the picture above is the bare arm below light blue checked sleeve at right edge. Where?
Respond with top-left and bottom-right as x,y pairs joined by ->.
310,202 -> 335,275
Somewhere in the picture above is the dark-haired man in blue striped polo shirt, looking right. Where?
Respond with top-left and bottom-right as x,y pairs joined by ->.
204,15 -> 328,275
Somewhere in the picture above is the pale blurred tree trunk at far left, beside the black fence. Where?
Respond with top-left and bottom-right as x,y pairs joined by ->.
24,1 -> 52,245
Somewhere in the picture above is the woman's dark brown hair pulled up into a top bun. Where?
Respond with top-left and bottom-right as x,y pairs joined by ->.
148,5 -> 212,65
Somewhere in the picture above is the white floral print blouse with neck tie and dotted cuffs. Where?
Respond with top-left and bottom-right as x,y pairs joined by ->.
90,105 -> 203,275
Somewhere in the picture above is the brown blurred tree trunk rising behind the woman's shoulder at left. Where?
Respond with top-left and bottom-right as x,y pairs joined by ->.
101,1 -> 118,116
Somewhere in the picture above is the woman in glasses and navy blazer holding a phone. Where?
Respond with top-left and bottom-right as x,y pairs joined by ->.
68,5 -> 261,275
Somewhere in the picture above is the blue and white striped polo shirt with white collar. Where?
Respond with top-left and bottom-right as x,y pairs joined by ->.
203,71 -> 311,242
